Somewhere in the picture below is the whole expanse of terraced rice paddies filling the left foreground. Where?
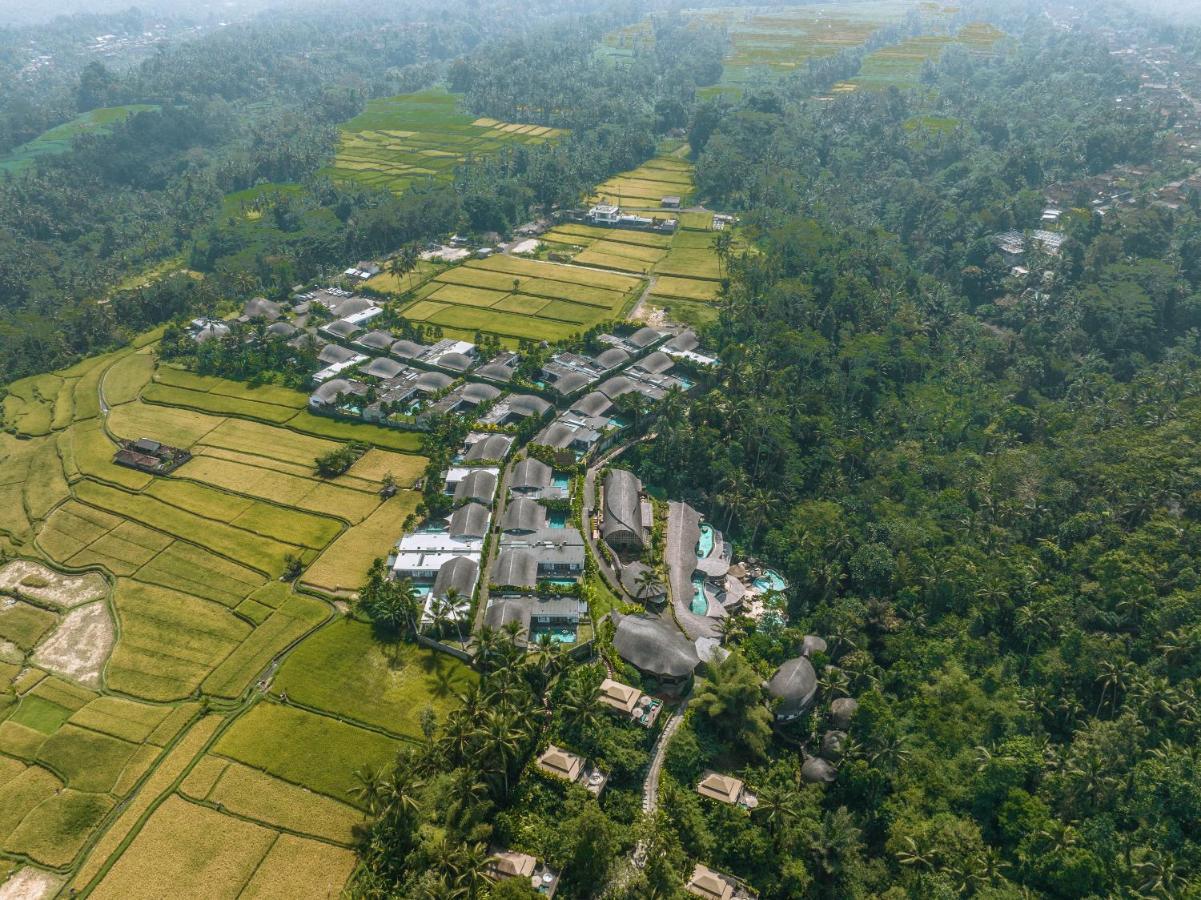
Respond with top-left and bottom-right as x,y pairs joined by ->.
0,338 -> 473,898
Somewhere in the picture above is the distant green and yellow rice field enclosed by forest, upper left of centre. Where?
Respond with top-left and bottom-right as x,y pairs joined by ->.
328,90 -> 566,193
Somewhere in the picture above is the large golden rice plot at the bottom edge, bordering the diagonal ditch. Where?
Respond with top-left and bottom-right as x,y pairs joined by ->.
91,797 -> 276,900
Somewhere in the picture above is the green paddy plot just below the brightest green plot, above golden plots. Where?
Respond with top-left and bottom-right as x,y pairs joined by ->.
213,696 -> 400,805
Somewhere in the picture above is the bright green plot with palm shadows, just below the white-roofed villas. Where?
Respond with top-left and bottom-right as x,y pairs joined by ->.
271,619 -> 476,738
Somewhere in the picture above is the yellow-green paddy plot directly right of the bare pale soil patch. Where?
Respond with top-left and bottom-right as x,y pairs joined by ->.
108,579 -> 251,701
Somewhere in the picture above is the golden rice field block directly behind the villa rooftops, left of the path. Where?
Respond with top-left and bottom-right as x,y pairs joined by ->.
402,248 -> 645,342
